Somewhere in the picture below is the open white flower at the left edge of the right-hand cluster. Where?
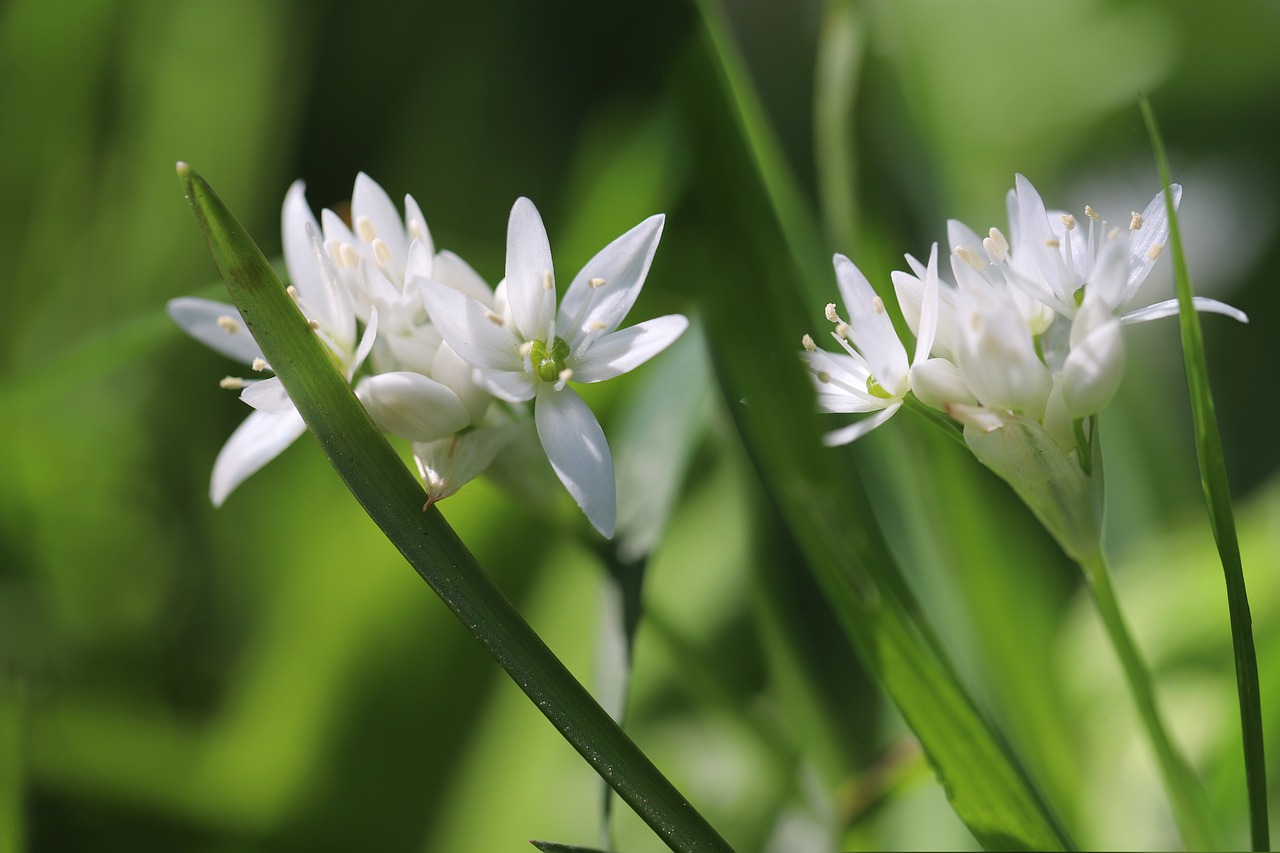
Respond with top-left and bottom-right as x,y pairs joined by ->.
800,246 -> 938,447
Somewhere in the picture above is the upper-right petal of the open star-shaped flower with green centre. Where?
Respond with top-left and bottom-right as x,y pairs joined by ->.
559,214 -> 667,338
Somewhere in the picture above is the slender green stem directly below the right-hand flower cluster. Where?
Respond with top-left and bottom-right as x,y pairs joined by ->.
1080,549 -> 1215,850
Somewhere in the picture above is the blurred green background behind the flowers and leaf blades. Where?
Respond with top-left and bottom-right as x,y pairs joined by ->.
0,0 -> 1280,850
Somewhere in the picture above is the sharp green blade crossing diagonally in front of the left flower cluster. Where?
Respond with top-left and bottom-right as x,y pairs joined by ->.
178,164 -> 730,850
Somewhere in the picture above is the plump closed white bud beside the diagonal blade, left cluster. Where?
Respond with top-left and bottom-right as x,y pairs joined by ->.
356,370 -> 471,442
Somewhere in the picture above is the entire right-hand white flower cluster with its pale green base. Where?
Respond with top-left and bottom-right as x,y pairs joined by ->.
801,175 -> 1248,560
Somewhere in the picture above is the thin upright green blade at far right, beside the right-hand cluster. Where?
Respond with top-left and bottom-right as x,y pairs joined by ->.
1140,96 -> 1271,850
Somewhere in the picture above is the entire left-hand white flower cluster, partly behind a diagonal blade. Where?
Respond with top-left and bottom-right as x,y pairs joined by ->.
176,173 -> 687,537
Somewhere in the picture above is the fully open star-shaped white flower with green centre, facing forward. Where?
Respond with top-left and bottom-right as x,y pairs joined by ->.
422,199 -> 689,537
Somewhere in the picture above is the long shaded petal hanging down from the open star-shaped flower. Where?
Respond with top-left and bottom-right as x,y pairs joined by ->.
534,384 -> 618,539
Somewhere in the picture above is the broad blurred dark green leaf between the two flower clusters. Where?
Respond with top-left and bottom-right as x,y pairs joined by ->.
672,31 -> 1073,849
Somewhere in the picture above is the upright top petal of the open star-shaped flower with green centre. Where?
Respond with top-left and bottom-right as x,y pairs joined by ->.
504,199 -> 556,340
